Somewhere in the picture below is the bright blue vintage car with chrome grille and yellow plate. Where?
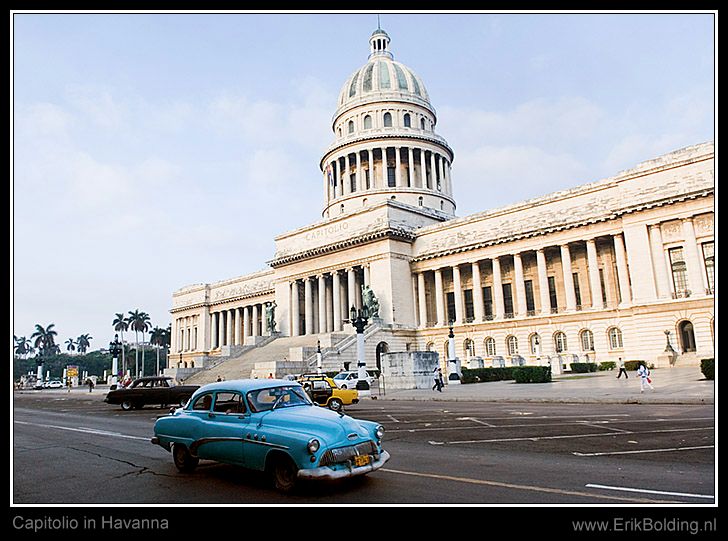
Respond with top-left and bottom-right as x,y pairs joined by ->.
152,379 -> 389,492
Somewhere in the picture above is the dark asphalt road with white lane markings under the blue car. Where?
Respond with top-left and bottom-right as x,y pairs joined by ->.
12,391 -> 715,505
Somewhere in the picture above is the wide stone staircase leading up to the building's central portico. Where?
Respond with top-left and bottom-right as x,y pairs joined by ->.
185,333 -> 349,385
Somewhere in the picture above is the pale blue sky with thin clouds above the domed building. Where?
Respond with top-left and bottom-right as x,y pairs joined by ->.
11,12 -> 717,349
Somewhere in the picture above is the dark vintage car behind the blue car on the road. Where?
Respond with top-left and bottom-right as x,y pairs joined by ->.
104,376 -> 200,411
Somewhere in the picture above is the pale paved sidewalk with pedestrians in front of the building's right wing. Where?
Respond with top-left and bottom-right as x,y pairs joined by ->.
377,366 -> 715,404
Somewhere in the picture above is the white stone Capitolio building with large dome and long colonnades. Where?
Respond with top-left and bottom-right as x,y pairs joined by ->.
168,29 -> 715,383
